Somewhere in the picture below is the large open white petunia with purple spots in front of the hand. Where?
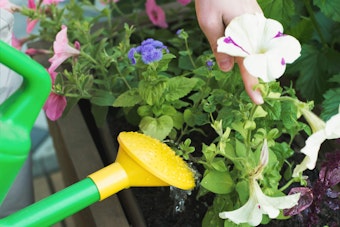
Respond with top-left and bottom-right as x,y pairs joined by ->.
217,14 -> 301,82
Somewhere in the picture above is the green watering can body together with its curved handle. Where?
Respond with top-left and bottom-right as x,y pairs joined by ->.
0,40 -> 51,204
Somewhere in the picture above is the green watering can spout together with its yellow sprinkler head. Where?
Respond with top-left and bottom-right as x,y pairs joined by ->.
0,132 -> 195,227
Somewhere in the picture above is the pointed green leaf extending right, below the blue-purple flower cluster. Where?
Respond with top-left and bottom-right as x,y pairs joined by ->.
165,77 -> 197,101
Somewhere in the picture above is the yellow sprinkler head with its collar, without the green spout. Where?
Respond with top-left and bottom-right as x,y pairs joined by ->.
89,132 -> 195,200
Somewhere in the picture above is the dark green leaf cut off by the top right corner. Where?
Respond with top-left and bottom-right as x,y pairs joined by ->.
313,0 -> 340,22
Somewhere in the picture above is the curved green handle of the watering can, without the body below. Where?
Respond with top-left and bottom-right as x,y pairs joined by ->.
0,41 -> 51,131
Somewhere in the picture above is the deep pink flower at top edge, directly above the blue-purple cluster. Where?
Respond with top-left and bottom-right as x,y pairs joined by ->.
145,0 -> 168,28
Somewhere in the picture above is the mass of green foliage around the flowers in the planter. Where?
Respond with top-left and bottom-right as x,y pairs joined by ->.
19,0 -> 340,226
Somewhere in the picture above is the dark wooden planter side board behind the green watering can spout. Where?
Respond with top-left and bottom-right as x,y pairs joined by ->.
49,106 -> 129,227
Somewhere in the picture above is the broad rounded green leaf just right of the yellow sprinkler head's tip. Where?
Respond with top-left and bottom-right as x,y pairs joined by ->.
201,170 -> 234,194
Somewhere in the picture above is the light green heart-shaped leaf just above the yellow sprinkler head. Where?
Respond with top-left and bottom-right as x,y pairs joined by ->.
139,115 -> 173,141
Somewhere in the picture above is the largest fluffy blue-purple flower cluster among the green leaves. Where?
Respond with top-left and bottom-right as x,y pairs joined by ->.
128,38 -> 169,64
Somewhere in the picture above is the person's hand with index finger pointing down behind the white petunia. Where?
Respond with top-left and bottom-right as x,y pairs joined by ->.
195,0 -> 263,104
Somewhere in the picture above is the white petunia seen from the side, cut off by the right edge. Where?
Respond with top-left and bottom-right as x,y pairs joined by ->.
293,108 -> 340,177
